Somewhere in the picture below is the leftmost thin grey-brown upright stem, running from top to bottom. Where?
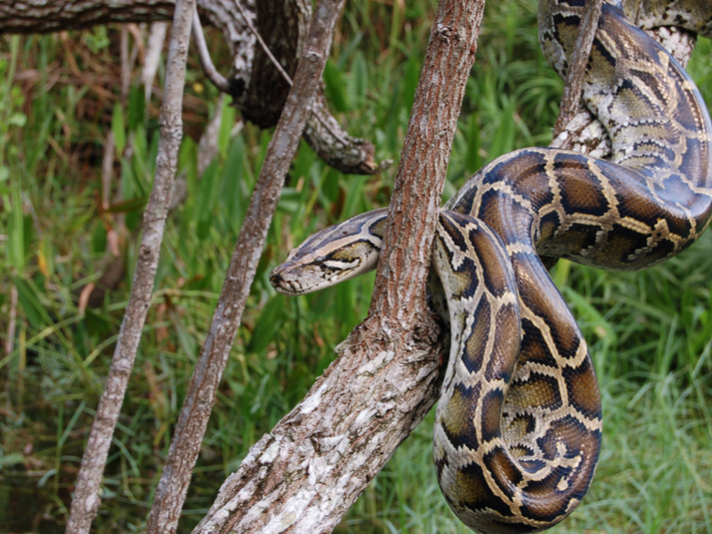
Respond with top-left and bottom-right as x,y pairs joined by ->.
66,0 -> 195,534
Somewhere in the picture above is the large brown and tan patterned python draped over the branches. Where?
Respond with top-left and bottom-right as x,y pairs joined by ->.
270,0 -> 712,534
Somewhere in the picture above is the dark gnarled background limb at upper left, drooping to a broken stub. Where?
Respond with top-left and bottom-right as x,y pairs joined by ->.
0,0 -> 379,174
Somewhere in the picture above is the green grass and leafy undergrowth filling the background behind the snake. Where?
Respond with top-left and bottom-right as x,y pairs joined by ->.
0,0 -> 712,534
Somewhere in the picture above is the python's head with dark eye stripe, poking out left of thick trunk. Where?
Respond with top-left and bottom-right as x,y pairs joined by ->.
269,209 -> 387,295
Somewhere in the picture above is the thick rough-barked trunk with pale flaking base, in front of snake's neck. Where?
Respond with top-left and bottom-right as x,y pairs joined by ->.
195,0 -> 484,533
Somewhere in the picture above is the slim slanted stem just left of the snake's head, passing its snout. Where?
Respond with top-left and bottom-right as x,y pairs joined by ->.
147,0 -> 344,534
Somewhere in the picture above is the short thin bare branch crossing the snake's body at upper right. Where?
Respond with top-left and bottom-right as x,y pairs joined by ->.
554,0 -> 603,142
